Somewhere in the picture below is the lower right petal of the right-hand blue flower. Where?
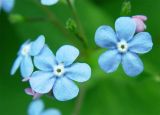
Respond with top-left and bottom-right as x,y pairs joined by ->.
122,52 -> 143,77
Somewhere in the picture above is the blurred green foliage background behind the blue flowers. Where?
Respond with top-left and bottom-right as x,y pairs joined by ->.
0,0 -> 160,115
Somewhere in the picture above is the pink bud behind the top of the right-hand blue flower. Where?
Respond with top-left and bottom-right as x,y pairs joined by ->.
132,15 -> 147,32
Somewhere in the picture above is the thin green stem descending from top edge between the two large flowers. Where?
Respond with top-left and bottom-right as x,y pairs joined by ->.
67,0 -> 88,47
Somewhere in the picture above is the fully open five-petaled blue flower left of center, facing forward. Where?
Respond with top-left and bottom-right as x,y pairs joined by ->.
29,45 -> 91,101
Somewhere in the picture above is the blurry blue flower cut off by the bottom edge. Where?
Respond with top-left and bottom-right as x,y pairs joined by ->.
28,100 -> 61,115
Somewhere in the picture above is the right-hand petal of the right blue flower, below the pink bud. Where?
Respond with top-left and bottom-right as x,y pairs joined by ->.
129,32 -> 153,54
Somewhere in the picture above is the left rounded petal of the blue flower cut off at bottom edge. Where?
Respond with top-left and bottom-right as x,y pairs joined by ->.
28,100 -> 44,115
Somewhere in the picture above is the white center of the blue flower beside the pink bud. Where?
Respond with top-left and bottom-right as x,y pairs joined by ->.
117,40 -> 128,53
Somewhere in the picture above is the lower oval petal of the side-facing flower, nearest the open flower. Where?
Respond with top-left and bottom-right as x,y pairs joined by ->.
20,56 -> 34,78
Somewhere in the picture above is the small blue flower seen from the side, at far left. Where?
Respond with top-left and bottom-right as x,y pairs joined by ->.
11,35 -> 45,78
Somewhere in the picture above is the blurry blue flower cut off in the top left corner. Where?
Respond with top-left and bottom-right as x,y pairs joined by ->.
0,0 -> 15,12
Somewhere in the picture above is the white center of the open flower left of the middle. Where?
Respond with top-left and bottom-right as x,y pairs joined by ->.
53,64 -> 65,77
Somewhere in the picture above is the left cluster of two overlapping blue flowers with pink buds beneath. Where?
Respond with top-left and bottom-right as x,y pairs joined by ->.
11,35 -> 91,101
